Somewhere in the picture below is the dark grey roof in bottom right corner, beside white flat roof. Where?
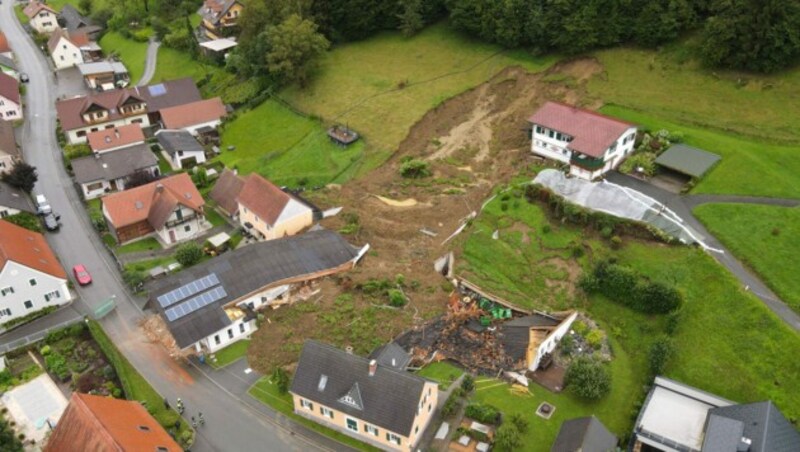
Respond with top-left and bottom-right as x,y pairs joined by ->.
703,401 -> 800,452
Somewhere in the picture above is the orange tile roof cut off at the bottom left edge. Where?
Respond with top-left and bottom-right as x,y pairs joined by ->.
44,392 -> 183,452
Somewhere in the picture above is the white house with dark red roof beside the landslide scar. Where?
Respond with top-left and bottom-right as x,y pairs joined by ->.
528,102 -> 636,180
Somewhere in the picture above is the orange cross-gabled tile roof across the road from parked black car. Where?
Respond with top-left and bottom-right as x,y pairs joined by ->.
102,173 -> 205,229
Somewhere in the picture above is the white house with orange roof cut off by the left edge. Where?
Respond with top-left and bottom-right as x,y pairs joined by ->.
0,220 -> 72,323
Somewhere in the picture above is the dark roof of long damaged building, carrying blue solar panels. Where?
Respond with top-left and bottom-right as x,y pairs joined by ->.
150,230 -> 357,348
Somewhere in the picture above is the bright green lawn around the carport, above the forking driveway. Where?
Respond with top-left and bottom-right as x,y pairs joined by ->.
602,107 -> 800,198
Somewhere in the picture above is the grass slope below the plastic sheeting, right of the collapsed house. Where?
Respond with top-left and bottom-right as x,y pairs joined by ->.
457,194 -> 800,450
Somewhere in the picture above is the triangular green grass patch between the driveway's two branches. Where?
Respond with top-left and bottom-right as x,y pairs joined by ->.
694,204 -> 800,312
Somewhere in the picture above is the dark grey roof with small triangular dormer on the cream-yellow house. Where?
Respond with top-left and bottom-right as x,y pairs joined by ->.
291,340 -> 427,436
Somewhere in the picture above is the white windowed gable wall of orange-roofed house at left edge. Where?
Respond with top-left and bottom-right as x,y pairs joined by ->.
0,261 -> 72,323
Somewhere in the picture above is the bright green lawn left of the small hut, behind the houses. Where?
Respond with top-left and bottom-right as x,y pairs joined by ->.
219,101 -> 363,186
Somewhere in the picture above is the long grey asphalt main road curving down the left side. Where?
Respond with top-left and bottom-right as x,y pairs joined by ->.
0,1 -> 325,451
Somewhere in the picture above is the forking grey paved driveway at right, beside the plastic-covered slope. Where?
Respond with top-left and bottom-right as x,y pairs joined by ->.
606,171 -> 800,331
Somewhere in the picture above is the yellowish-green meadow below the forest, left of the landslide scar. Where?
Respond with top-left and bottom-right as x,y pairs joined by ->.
281,23 -> 556,172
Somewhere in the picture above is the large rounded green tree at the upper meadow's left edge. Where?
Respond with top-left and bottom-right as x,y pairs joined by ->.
267,14 -> 330,86
